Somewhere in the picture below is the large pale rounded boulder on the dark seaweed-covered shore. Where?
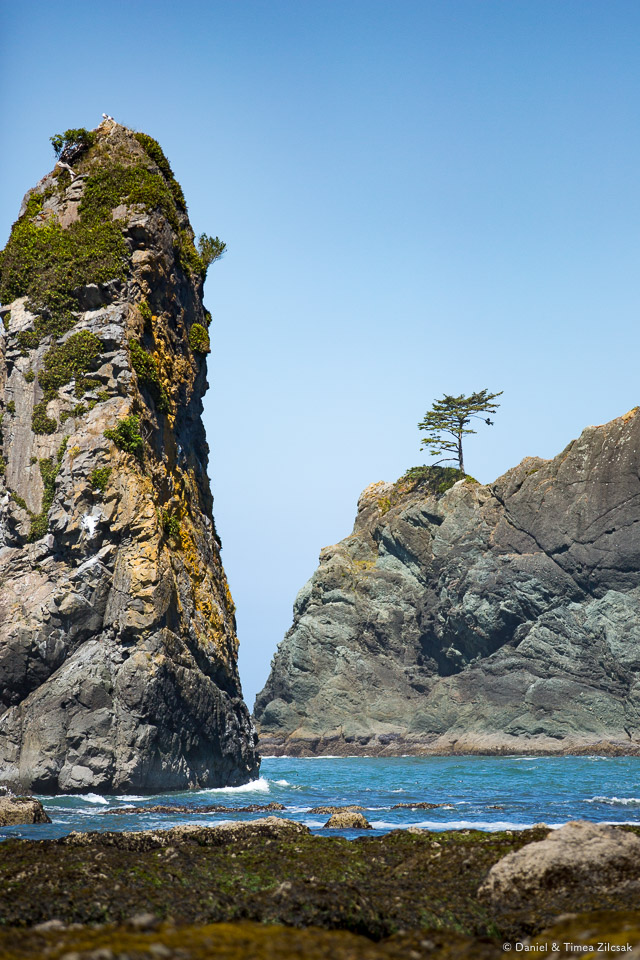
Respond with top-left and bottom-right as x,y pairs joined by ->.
478,821 -> 640,911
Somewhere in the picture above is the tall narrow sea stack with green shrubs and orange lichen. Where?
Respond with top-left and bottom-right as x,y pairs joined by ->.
0,121 -> 258,793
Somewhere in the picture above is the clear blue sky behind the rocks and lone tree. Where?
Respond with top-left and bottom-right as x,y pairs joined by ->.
0,0 -> 640,705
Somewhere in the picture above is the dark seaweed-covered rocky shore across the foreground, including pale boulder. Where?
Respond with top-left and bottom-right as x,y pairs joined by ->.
0,816 -> 640,960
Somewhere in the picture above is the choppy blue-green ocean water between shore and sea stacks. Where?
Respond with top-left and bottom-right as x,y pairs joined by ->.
0,755 -> 640,839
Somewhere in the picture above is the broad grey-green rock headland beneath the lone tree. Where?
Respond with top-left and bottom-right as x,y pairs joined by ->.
255,408 -> 640,754
